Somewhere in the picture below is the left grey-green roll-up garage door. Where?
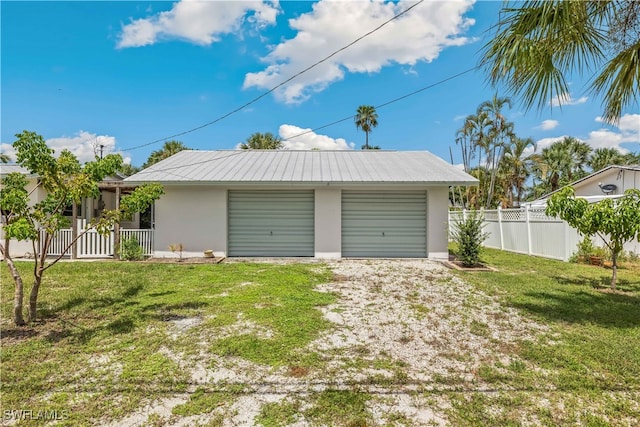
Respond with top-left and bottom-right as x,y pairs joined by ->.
229,190 -> 314,256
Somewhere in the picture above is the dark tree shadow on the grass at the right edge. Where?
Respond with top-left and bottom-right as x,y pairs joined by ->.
514,291 -> 640,328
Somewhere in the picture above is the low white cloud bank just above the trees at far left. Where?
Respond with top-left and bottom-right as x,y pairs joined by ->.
1,130 -> 131,167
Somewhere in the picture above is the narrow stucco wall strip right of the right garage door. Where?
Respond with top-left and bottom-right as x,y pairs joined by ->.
427,187 -> 449,260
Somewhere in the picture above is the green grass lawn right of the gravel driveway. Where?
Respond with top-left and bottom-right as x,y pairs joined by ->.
444,249 -> 640,426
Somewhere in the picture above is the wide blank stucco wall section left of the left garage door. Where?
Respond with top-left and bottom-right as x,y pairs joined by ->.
154,186 -> 227,257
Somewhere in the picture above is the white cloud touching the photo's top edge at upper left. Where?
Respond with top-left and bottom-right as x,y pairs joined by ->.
117,0 -> 280,48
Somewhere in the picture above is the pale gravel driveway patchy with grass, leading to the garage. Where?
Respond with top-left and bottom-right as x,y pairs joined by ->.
107,260 -> 546,426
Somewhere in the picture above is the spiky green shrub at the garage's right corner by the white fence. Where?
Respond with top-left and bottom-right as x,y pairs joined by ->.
451,211 -> 489,267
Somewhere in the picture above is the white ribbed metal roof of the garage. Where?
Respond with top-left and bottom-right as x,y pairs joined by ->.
125,150 -> 477,185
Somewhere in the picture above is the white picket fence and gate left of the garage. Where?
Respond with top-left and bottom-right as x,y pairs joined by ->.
40,220 -> 153,258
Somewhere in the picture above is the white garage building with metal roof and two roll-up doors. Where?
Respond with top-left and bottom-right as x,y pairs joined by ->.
125,150 -> 477,259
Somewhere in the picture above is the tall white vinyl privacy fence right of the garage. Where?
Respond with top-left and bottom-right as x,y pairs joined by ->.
449,206 -> 640,261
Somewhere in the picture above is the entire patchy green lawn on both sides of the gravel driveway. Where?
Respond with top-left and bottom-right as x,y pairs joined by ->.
0,249 -> 640,426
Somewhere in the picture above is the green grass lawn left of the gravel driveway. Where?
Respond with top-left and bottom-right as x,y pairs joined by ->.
0,262 -> 334,425
